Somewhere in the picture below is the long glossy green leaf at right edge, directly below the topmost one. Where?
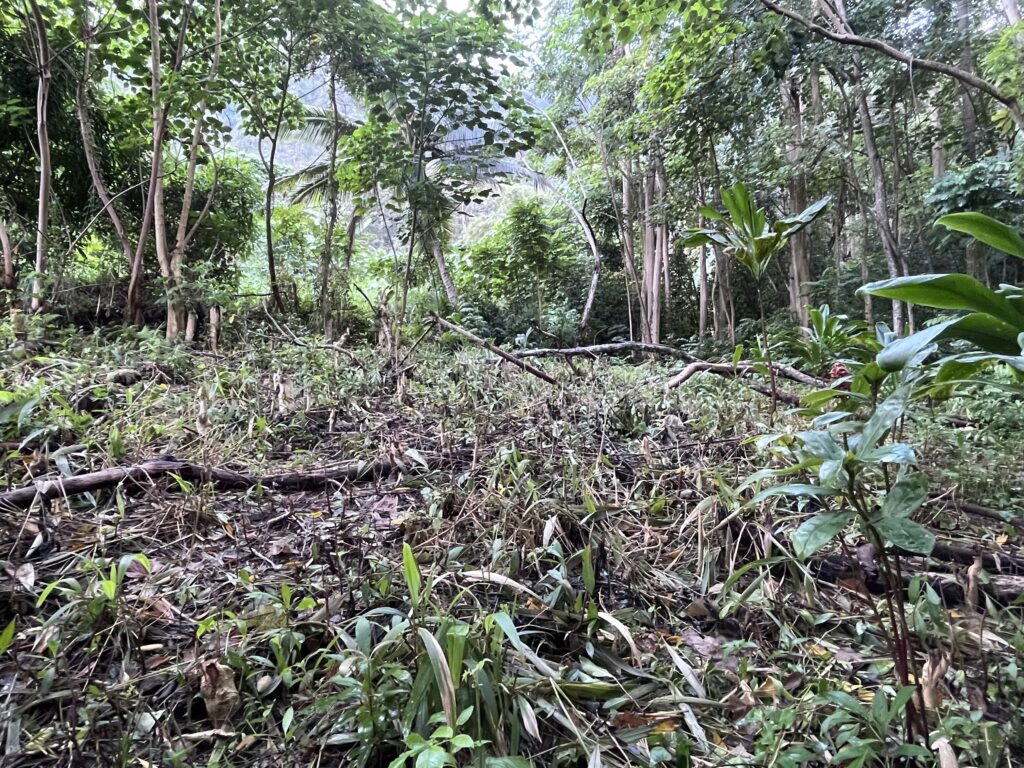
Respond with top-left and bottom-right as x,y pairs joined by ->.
857,273 -> 1024,326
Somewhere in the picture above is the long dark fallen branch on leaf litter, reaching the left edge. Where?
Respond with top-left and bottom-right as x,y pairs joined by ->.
0,456 -> 452,509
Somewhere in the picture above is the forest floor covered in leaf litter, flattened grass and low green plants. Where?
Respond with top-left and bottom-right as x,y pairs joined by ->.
0,333 -> 1024,768
